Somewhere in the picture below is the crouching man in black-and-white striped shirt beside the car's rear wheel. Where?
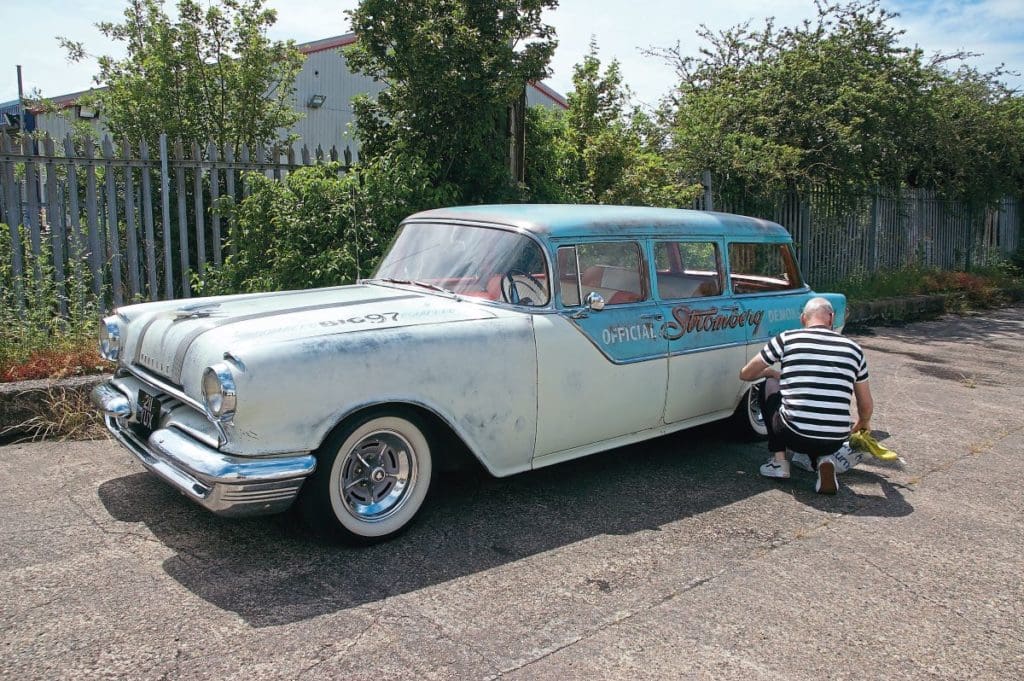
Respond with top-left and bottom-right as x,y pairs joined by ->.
739,298 -> 874,495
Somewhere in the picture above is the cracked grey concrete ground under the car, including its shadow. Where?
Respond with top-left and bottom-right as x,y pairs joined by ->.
0,308 -> 1024,680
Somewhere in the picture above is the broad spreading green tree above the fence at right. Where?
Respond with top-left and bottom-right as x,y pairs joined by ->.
655,0 -> 1020,196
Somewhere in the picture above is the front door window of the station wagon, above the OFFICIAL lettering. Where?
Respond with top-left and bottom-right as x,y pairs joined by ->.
558,242 -> 647,305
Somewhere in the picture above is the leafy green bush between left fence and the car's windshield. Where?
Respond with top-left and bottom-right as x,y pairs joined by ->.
197,155 -> 455,294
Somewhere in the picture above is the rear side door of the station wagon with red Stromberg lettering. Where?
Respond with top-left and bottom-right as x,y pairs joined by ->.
652,237 -> 751,423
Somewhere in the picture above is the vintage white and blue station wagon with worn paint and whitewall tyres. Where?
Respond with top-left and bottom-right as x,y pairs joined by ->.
93,205 -> 846,542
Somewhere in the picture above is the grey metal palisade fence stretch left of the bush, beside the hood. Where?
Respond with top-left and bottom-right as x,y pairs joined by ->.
0,134 -> 351,313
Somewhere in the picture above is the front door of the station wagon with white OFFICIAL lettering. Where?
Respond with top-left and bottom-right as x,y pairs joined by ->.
535,240 -> 668,458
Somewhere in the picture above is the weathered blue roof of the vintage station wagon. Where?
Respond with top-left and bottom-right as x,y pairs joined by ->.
408,204 -> 790,240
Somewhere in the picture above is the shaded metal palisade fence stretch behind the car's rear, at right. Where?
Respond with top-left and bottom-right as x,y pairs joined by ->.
716,189 -> 1024,287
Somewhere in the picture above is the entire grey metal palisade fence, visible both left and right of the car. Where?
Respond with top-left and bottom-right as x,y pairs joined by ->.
0,129 -> 1024,312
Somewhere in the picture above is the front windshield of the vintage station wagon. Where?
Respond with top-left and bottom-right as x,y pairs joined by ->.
374,222 -> 550,306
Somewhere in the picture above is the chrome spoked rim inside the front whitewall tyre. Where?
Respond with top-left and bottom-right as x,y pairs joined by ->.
337,430 -> 419,522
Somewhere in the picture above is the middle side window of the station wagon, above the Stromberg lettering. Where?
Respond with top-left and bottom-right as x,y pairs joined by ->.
654,242 -> 722,300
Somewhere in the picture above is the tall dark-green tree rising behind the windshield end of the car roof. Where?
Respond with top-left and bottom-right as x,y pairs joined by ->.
345,0 -> 557,203
